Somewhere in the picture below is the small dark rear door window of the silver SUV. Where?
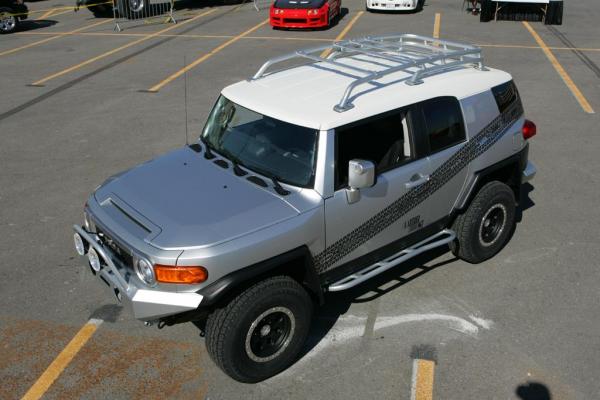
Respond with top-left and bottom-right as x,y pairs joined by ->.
421,97 -> 465,153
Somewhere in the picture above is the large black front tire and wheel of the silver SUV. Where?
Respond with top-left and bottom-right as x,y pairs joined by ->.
206,276 -> 313,383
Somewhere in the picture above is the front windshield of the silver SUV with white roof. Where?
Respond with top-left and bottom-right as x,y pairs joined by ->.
201,96 -> 317,187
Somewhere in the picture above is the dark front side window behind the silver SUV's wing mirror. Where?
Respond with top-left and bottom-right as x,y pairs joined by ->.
335,111 -> 411,190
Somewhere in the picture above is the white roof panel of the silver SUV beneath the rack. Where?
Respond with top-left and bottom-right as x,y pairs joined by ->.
222,55 -> 512,130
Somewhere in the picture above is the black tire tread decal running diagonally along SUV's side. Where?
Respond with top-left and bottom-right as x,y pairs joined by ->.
314,97 -> 523,273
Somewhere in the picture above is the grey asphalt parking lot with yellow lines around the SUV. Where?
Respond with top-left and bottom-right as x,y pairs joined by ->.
0,0 -> 600,400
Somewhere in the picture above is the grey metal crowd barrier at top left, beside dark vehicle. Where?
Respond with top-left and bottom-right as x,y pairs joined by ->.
113,0 -> 177,32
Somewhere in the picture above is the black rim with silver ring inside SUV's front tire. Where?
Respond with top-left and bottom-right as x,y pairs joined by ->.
246,307 -> 295,362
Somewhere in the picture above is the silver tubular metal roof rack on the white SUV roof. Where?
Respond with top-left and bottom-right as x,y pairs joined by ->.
251,34 -> 486,112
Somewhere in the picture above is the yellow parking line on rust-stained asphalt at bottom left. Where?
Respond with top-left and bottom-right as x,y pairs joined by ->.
21,319 -> 102,400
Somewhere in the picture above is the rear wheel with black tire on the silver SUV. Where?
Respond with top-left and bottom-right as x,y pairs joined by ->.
450,181 -> 516,264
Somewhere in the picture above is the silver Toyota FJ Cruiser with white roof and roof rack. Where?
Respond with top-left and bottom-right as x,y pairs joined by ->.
74,34 -> 536,382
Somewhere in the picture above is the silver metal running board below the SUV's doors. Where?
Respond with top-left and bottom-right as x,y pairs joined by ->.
328,229 -> 456,292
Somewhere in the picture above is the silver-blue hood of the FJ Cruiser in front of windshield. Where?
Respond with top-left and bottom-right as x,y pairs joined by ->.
95,147 -> 298,249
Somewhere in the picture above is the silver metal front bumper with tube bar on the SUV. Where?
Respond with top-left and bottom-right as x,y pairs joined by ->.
73,225 -> 203,321
